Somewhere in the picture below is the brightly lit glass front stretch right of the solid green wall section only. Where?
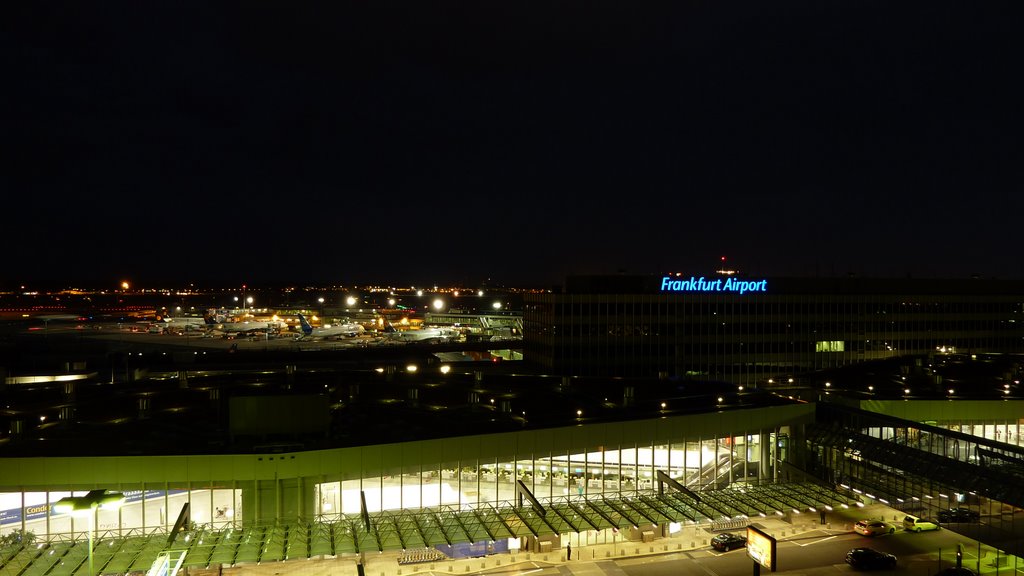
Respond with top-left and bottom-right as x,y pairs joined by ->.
317,434 -> 770,519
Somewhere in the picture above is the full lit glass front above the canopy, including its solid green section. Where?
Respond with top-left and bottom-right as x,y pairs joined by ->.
0,426 -> 790,538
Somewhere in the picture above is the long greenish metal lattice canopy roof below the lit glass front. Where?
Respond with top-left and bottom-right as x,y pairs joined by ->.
0,483 -> 856,576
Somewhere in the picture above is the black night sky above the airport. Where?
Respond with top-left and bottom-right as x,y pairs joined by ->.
0,0 -> 1024,287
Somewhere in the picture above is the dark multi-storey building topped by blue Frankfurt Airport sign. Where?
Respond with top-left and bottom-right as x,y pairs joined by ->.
523,275 -> 1024,384
